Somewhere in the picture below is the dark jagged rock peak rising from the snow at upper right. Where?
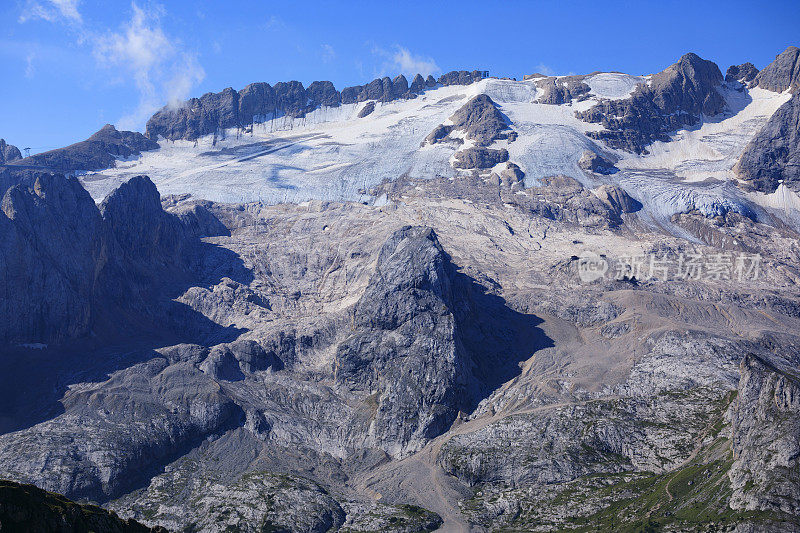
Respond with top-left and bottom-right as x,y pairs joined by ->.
576,53 -> 725,153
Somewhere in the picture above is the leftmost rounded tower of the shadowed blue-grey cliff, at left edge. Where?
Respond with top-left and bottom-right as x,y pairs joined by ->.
0,172 -> 103,343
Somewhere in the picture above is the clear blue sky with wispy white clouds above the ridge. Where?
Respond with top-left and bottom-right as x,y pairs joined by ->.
0,0 -> 800,152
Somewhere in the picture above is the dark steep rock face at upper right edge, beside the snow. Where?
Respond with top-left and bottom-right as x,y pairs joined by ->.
735,94 -> 800,193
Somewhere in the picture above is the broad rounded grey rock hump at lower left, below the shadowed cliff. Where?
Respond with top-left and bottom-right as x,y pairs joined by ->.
0,358 -> 243,502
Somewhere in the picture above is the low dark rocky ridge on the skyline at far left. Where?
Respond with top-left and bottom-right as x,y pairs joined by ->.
6,124 -> 158,173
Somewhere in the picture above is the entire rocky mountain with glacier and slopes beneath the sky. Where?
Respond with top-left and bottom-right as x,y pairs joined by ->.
0,42 -> 800,533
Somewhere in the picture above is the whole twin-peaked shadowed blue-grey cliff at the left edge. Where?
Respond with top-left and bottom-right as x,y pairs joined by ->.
0,172 -> 219,344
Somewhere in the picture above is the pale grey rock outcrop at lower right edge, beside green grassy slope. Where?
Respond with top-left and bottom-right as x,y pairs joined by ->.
729,355 -> 800,516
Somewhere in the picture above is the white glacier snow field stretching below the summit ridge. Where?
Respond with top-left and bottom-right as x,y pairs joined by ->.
82,73 -> 798,224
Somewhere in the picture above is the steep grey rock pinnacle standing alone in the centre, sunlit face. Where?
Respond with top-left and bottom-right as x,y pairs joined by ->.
334,227 -> 470,455
